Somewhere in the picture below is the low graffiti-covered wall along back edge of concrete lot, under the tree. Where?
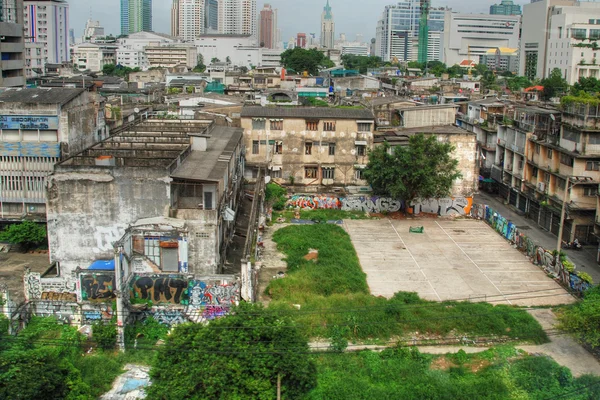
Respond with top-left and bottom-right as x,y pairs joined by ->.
286,195 -> 473,216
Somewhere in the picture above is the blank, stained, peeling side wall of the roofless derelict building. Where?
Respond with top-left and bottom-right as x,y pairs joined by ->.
47,165 -> 170,275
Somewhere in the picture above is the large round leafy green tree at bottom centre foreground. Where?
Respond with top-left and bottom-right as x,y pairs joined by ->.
148,303 -> 317,400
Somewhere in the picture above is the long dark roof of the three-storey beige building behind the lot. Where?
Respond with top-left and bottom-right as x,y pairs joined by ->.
241,106 -> 375,119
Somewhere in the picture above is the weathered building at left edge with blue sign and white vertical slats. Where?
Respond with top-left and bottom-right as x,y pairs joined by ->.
0,88 -> 108,221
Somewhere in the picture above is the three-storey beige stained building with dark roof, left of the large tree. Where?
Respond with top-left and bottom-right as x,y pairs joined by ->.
241,106 -> 375,187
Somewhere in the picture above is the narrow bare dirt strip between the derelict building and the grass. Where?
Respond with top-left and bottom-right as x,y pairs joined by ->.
258,224 -> 288,306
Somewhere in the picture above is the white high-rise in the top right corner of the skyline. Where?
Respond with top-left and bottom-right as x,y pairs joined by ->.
544,2 -> 600,85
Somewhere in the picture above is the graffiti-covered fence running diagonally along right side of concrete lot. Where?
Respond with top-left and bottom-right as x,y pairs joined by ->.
471,204 -> 592,296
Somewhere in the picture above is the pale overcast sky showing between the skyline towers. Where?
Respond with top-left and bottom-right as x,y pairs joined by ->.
69,0 -> 529,41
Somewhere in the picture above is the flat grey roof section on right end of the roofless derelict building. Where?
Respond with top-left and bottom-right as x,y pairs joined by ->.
171,125 -> 244,182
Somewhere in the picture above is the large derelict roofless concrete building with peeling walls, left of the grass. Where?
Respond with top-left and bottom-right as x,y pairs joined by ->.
47,115 -> 244,287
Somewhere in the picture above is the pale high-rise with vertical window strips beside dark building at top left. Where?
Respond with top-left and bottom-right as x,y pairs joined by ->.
23,0 -> 70,64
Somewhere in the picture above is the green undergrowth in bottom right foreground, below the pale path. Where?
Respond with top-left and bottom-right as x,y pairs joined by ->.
307,347 -> 600,400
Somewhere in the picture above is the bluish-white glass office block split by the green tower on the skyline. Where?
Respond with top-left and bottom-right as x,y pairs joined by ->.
375,0 -> 449,61
